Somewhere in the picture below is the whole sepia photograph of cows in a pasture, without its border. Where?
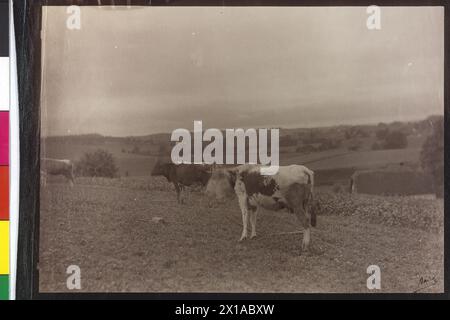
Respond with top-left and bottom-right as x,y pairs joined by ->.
38,6 -> 444,293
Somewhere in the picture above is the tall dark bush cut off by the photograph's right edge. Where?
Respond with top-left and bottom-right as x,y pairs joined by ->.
420,118 -> 444,198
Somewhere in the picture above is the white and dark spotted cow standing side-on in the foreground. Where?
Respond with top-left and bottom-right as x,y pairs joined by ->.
206,164 -> 316,250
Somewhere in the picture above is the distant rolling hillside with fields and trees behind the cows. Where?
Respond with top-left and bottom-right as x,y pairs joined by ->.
41,116 -> 442,179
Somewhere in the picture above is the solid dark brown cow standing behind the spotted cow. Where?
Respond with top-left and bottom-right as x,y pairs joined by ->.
151,161 -> 211,203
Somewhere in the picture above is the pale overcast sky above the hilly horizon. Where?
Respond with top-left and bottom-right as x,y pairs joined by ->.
42,7 -> 444,136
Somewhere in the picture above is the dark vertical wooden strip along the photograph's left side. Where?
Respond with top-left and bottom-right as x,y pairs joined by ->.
13,0 -> 41,300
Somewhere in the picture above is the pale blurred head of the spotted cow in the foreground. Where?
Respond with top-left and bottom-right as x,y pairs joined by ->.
205,169 -> 237,201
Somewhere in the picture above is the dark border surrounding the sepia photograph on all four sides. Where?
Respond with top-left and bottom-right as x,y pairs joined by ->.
13,0 -> 450,300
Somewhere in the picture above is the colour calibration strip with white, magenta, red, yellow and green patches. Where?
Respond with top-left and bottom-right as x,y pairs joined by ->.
0,1 -> 10,300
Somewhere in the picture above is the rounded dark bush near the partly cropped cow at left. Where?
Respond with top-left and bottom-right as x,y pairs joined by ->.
76,149 -> 118,178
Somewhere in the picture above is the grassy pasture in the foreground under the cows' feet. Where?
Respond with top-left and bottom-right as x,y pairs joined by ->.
39,177 -> 444,292
